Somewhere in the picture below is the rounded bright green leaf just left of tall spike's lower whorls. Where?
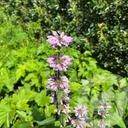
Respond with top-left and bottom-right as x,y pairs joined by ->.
35,90 -> 51,107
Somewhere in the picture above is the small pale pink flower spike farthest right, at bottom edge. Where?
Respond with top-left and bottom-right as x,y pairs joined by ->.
98,102 -> 111,128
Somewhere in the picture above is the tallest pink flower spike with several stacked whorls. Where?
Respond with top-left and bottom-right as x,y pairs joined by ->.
47,31 -> 72,127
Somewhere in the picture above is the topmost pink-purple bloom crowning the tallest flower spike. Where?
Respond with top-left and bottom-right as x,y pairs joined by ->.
47,31 -> 72,48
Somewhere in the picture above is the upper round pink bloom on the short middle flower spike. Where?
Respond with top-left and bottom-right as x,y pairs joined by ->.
74,105 -> 88,118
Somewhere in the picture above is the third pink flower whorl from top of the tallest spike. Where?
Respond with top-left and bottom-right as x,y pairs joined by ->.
47,75 -> 69,91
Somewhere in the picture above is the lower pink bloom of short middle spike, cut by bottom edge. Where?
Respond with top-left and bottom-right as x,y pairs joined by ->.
71,118 -> 86,128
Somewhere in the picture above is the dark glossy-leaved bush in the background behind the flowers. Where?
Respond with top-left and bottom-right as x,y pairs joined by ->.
0,0 -> 128,76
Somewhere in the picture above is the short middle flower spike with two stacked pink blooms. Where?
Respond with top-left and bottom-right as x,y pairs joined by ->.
71,105 -> 88,128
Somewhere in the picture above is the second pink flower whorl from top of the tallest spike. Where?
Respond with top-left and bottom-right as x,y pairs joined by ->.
47,55 -> 71,71
